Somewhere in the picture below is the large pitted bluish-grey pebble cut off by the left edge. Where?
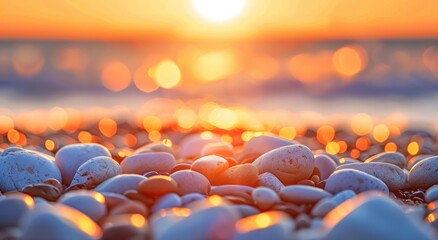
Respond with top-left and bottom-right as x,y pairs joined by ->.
0,147 -> 61,192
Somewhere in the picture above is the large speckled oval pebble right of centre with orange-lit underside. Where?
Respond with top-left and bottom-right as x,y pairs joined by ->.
252,144 -> 315,184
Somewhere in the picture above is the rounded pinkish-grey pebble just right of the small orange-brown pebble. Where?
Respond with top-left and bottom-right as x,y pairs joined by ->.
170,170 -> 211,195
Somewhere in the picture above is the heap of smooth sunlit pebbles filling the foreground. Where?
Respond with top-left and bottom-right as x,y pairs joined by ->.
0,134 -> 438,240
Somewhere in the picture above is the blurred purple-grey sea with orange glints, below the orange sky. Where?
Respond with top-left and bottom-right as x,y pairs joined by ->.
0,39 -> 438,127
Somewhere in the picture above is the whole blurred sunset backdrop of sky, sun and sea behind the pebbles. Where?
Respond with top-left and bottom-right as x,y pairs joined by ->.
0,0 -> 438,144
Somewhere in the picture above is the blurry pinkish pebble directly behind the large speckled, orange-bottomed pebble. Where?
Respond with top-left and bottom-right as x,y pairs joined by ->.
239,135 -> 294,163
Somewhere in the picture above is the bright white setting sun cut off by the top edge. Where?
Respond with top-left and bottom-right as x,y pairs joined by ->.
192,0 -> 246,22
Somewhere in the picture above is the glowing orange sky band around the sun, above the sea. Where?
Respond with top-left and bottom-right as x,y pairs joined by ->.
0,0 -> 438,40
